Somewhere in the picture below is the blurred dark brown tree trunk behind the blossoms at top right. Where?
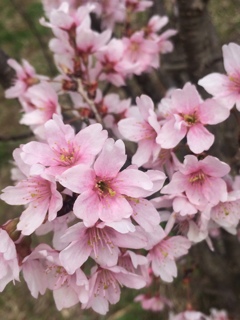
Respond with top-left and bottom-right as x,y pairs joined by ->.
177,0 -> 222,83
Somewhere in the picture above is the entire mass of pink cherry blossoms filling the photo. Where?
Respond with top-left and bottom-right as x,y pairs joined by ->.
0,0 -> 240,320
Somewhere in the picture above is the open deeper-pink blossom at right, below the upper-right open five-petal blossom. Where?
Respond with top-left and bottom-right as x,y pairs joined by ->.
161,155 -> 230,206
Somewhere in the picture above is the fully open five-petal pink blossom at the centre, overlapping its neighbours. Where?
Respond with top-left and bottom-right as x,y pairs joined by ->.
58,139 -> 153,227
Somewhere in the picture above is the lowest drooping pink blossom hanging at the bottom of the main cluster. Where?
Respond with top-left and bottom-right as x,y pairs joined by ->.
83,266 -> 146,314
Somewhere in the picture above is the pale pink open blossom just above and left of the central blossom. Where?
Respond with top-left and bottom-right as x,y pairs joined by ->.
21,115 -> 107,175
